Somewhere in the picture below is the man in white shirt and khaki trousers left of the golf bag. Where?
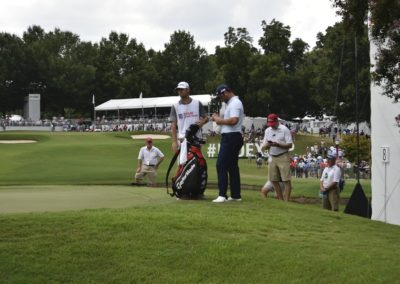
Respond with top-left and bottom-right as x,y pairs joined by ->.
135,137 -> 164,186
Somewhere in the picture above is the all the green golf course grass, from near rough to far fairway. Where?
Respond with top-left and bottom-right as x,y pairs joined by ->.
0,132 -> 400,283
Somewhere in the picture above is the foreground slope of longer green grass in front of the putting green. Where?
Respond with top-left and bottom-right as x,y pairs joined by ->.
0,188 -> 400,283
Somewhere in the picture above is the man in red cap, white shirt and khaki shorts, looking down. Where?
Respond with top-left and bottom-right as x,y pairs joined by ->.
262,113 -> 293,201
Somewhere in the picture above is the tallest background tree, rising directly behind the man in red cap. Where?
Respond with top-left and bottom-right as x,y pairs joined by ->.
249,20 -> 310,119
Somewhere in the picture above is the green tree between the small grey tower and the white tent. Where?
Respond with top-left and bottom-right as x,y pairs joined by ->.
43,29 -> 97,117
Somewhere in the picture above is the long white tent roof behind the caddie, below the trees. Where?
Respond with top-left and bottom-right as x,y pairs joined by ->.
95,94 -> 211,111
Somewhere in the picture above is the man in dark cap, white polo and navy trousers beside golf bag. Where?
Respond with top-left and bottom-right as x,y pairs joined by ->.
211,84 -> 244,203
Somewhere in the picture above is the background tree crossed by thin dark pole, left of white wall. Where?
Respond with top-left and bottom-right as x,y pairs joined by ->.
307,23 -> 370,122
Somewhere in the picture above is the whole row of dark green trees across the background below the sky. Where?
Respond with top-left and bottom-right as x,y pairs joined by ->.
0,13 -> 382,122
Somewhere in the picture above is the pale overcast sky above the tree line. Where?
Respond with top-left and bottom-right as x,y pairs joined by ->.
0,0 -> 340,53
